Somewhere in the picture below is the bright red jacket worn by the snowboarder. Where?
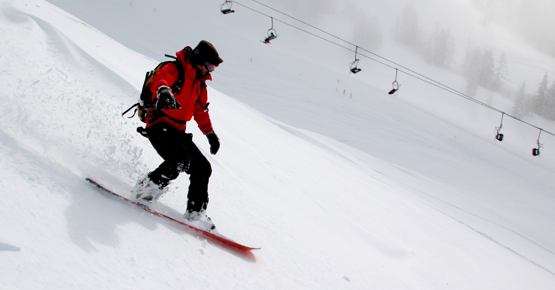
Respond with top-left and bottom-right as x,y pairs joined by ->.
146,47 -> 213,134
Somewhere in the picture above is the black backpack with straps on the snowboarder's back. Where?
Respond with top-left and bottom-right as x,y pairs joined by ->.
121,54 -> 185,124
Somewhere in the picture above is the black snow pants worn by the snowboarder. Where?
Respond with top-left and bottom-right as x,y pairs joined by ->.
146,123 -> 212,211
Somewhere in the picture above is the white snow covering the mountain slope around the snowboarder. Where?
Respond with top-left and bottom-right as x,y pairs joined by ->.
0,0 -> 555,289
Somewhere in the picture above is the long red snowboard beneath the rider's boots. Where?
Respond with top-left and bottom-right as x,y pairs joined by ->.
85,177 -> 260,251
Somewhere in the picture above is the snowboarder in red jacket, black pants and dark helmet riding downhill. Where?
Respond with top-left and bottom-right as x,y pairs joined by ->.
132,40 -> 223,229
